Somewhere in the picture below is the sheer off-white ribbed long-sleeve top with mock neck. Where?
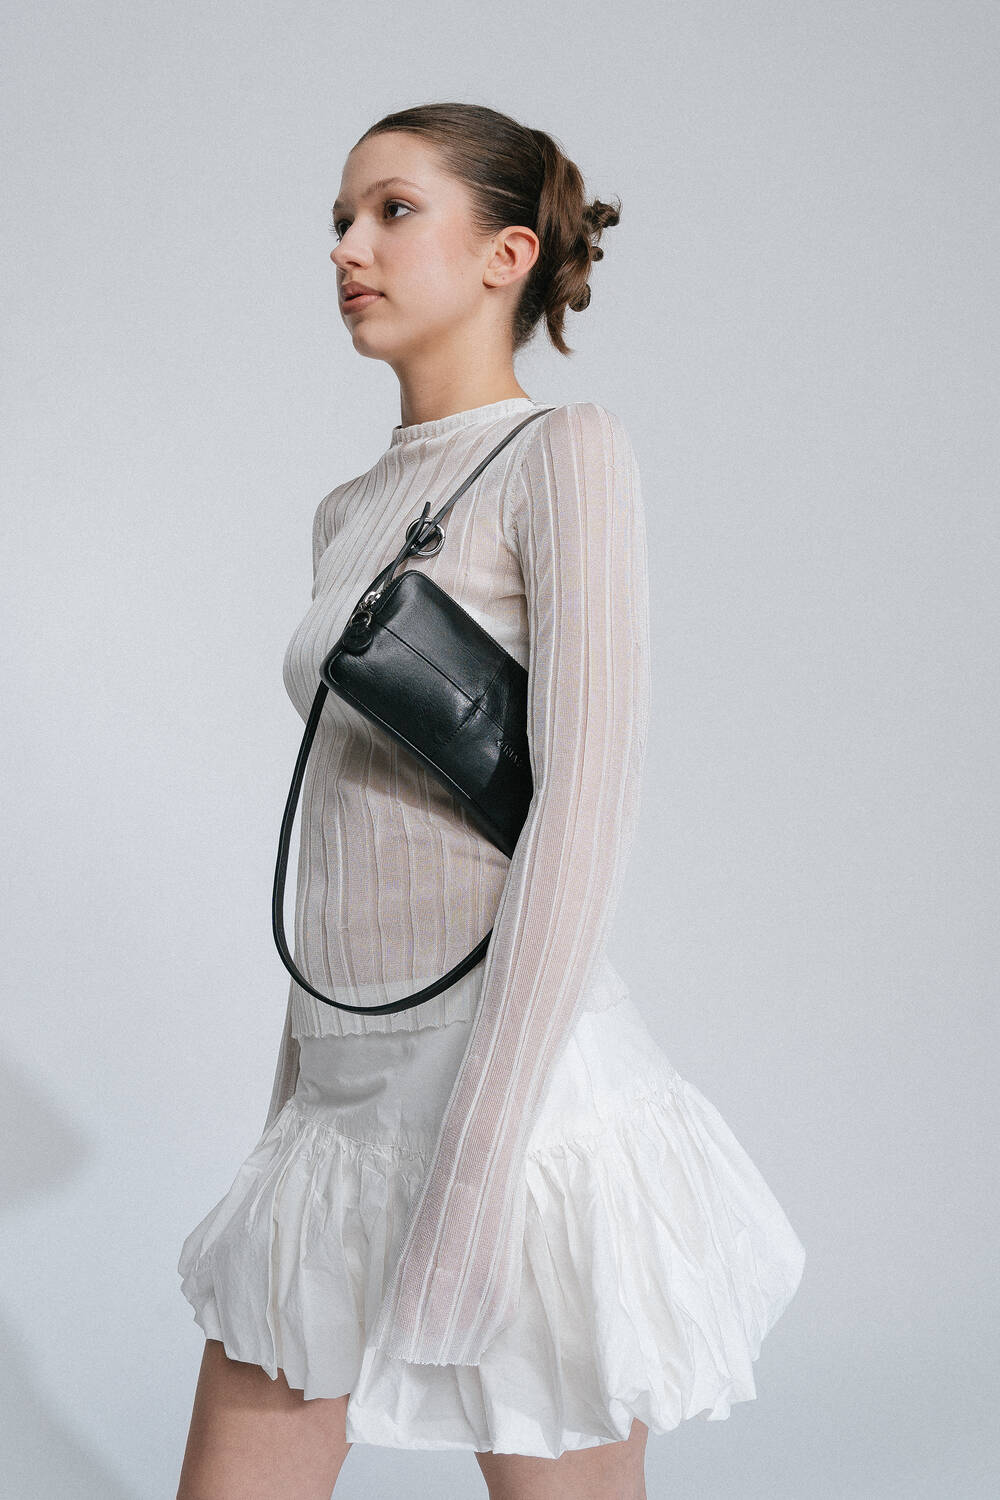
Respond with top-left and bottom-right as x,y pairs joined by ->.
267,398 -> 649,1364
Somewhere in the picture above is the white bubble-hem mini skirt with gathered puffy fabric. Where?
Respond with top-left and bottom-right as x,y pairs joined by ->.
177,966 -> 805,1458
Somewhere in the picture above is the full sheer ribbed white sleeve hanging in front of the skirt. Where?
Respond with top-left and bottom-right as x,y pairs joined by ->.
370,402 -> 649,1364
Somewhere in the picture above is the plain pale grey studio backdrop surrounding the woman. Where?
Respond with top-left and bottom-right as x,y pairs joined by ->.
0,0 -> 1000,1500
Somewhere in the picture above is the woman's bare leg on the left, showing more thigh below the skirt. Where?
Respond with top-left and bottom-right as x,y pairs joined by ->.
177,1338 -> 351,1500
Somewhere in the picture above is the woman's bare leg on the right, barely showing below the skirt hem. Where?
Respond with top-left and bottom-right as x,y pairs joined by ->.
475,1418 -> 649,1500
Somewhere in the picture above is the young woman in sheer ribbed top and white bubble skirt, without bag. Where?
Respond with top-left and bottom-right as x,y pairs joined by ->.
178,104 -> 804,1500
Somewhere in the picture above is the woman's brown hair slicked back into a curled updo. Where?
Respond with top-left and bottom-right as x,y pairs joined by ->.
350,104 -> 622,354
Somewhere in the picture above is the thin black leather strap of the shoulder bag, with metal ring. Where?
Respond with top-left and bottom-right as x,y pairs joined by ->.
271,407 -> 555,1016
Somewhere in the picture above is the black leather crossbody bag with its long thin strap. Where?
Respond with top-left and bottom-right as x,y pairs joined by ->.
271,407 -> 553,1016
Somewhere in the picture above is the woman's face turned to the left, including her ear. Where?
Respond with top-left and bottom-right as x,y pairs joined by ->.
330,131 -> 535,365
